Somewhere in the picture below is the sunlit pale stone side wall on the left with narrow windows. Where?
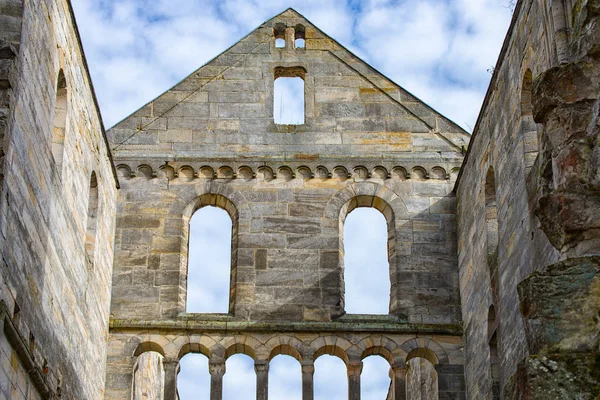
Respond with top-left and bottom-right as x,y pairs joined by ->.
0,0 -> 116,399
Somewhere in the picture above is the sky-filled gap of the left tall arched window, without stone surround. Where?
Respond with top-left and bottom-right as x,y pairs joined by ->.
186,206 -> 232,313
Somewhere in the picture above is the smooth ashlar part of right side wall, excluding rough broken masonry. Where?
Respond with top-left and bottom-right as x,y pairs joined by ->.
457,0 -> 562,399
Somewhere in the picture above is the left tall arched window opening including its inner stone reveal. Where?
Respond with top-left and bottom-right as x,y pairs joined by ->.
184,194 -> 237,313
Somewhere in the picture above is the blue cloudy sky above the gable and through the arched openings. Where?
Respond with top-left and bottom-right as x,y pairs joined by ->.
72,0 -> 511,400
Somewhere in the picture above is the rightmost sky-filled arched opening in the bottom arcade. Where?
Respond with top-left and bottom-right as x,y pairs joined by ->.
360,355 -> 391,399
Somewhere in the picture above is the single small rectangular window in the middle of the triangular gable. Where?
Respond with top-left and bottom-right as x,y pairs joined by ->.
273,67 -> 306,125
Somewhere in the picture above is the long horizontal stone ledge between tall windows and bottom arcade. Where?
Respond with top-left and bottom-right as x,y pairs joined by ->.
110,314 -> 463,336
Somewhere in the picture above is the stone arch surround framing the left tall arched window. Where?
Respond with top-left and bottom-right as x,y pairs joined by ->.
169,181 -> 249,314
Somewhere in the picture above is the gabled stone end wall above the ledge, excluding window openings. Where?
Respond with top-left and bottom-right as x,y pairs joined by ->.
108,10 -> 469,323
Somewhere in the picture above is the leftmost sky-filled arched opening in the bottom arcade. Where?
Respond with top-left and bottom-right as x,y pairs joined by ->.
177,353 -> 210,400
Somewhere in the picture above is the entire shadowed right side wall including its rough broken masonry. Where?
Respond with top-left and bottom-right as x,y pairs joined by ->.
457,0 -> 600,399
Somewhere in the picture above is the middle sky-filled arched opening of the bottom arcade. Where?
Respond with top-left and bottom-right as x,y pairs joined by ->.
269,354 -> 302,400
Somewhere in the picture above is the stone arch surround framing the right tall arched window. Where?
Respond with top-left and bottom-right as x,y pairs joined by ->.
324,182 -> 408,313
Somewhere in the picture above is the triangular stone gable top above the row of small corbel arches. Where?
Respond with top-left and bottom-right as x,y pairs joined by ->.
109,9 -> 470,158
